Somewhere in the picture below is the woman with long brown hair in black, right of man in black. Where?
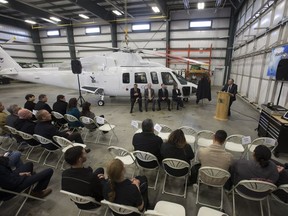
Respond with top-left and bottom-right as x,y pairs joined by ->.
161,129 -> 194,176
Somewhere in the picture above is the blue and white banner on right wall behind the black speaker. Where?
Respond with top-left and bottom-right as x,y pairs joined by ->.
267,45 -> 288,77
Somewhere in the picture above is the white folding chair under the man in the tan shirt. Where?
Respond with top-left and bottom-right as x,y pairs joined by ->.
196,167 -> 230,210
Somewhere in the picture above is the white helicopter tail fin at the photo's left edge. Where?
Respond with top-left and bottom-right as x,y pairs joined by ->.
0,47 -> 22,75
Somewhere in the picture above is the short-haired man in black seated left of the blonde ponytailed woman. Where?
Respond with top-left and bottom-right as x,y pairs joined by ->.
62,146 -> 106,209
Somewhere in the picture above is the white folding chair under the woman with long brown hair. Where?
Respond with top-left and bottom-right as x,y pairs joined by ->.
162,158 -> 191,198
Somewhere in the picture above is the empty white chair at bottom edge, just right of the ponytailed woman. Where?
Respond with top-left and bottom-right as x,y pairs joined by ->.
144,201 -> 187,216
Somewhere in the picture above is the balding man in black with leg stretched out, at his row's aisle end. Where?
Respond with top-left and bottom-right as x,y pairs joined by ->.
34,110 -> 84,150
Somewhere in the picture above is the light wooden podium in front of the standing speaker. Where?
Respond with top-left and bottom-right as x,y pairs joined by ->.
214,92 -> 230,121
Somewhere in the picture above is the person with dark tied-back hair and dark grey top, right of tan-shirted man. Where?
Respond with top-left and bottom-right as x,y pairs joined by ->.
225,145 -> 279,196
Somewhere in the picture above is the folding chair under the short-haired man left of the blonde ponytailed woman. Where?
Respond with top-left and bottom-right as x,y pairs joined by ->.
60,190 -> 102,216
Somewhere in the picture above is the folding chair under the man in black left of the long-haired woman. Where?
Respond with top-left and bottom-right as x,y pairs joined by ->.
132,151 -> 160,190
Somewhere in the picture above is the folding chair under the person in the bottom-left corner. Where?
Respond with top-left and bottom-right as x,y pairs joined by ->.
0,186 -> 46,216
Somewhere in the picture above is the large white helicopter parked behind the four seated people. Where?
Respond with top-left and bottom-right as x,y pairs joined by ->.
0,47 -> 207,106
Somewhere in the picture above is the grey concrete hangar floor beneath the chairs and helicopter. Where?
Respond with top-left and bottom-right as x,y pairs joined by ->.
0,82 -> 288,216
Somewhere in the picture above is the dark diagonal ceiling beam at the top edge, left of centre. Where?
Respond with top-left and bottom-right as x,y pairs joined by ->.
69,0 -> 115,22
